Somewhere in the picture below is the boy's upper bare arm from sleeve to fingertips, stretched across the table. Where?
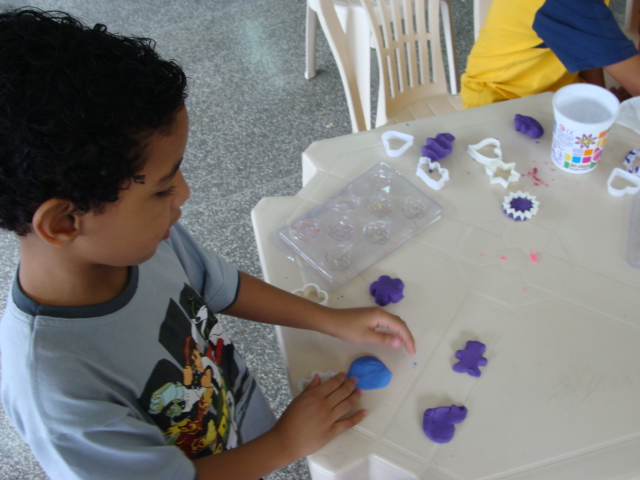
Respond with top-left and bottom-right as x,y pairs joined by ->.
223,272 -> 415,354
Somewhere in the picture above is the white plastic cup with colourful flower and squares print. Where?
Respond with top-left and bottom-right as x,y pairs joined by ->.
551,83 -> 620,173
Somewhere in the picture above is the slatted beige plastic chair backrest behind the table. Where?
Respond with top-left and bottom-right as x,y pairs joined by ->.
361,0 -> 448,125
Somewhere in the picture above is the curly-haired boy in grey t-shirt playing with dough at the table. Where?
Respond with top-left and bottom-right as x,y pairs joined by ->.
0,9 -> 415,480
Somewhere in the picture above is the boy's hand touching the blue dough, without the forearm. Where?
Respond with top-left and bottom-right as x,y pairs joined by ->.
272,373 -> 367,460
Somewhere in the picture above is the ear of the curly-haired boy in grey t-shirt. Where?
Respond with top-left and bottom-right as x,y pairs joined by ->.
32,198 -> 80,247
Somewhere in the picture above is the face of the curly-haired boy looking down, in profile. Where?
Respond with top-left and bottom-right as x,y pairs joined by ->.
74,108 -> 189,267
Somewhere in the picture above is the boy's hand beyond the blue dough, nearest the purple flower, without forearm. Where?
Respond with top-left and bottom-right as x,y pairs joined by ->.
327,307 -> 416,355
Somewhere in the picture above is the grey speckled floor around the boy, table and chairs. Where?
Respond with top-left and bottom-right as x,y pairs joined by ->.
0,0 -> 624,480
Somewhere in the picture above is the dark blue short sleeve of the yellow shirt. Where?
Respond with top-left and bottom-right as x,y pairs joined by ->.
533,0 -> 638,73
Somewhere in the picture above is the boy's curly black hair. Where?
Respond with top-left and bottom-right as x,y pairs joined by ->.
0,8 -> 187,235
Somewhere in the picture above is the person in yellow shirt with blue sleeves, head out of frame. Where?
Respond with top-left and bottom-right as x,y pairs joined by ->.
461,0 -> 640,108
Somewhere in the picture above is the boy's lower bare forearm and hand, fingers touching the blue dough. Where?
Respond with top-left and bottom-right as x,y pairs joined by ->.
194,373 -> 366,480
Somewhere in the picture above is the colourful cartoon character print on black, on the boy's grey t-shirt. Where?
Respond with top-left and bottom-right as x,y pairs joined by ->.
138,285 -> 256,459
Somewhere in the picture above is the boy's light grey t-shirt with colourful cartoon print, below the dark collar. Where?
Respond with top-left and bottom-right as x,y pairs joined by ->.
0,224 -> 275,480
